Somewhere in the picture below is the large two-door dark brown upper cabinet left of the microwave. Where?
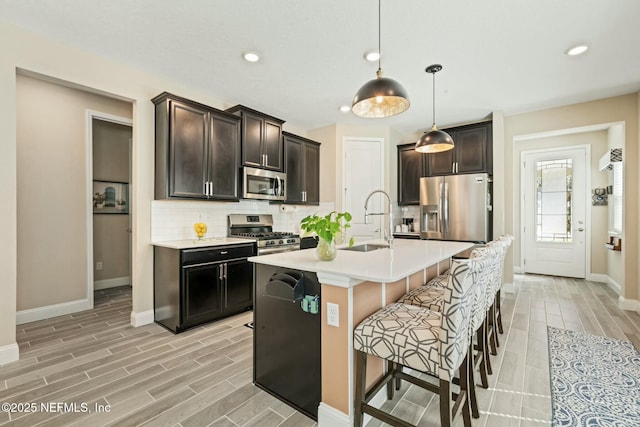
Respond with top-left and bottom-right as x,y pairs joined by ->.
152,92 -> 240,201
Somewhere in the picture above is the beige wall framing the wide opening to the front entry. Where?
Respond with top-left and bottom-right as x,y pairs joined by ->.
502,93 -> 640,300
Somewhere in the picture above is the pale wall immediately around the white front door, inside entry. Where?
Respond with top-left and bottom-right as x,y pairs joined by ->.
512,130 -> 608,275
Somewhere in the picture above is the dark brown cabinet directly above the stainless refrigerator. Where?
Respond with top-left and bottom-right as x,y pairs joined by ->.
427,122 -> 493,176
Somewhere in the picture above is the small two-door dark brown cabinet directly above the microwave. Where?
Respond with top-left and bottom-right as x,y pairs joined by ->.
226,105 -> 284,172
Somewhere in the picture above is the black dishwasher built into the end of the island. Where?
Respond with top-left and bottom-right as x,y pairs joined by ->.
253,264 -> 322,420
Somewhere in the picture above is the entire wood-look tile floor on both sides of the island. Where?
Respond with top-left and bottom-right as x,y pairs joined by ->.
0,275 -> 640,427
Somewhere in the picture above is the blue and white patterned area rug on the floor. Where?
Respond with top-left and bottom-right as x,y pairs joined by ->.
547,326 -> 640,427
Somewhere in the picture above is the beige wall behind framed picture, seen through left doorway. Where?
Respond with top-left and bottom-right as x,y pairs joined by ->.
93,119 -> 131,289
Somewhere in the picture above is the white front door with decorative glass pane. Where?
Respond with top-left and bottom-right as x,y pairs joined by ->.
521,147 -> 588,278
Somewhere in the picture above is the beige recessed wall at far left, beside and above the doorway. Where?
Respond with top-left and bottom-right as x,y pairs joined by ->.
16,75 -> 131,311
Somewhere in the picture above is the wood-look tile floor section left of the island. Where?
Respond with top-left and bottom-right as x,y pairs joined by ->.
0,287 -> 315,427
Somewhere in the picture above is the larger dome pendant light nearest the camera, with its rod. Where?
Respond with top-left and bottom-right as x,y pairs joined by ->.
351,0 -> 409,118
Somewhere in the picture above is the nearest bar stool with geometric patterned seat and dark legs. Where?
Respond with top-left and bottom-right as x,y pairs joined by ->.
353,259 -> 480,427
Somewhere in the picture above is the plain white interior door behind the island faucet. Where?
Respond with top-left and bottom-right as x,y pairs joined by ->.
342,138 -> 388,241
